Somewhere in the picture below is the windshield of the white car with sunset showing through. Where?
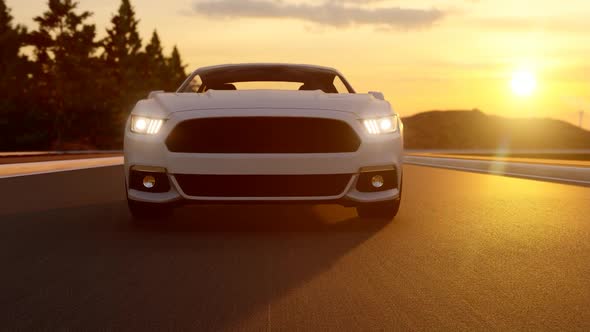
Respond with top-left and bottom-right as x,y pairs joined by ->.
179,65 -> 354,93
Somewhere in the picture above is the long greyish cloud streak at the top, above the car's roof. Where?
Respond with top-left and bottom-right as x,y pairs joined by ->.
193,0 -> 445,29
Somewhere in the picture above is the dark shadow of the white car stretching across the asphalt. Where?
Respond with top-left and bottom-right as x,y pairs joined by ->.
0,201 -> 395,330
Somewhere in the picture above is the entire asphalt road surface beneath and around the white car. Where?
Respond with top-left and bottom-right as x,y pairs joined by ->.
0,166 -> 590,331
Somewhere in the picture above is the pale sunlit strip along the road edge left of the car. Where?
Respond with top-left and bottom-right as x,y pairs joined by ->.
0,157 -> 123,179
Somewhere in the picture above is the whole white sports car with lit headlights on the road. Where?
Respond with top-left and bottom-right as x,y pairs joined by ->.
124,64 -> 403,220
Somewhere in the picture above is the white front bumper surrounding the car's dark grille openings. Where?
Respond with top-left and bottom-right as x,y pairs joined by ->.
124,110 -> 403,205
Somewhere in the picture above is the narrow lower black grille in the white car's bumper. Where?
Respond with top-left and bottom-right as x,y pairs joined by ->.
174,174 -> 352,197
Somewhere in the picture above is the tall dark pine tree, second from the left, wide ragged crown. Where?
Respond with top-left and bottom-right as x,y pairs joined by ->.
31,0 -> 100,148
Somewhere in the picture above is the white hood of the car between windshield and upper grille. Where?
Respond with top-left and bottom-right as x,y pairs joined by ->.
136,90 -> 392,117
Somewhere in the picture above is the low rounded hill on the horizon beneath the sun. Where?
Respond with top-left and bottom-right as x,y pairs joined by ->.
402,110 -> 590,149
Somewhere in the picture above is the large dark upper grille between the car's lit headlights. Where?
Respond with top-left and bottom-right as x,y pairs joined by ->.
166,117 -> 360,153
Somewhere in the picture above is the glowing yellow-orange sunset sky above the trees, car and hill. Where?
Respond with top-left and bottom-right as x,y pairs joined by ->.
7,0 -> 590,129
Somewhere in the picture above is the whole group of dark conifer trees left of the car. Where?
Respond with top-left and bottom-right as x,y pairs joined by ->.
0,0 -> 185,150
